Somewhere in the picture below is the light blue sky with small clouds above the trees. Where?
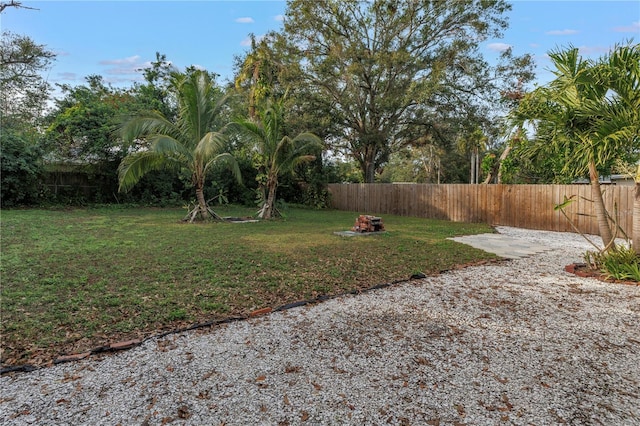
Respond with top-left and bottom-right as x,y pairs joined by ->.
0,0 -> 640,91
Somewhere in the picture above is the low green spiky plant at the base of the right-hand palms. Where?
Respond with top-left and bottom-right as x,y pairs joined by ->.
584,246 -> 640,281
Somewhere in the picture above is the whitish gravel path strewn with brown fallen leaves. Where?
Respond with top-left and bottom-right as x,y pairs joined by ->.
0,227 -> 640,425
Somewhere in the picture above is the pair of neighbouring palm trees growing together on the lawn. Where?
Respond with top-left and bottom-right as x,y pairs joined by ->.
118,70 -> 322,222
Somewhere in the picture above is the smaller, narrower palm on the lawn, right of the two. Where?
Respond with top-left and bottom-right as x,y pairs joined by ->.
234,101 -> 323,219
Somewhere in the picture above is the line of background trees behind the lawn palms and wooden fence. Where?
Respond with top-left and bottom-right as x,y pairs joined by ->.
0,0 -> 635,212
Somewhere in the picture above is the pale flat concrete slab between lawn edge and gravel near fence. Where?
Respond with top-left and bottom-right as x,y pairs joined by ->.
449,234 -> 551,259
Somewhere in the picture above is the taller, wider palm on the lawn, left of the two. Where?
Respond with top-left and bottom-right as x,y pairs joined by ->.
118,70 -> 240,222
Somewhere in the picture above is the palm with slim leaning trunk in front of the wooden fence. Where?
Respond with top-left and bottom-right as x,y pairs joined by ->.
515,45 -> 640,250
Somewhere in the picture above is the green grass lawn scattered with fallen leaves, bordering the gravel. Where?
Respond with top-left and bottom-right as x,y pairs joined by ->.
0,206 -> 495,365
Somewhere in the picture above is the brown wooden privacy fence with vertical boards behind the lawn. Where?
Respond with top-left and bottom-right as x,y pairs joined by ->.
329,183 -> 634,237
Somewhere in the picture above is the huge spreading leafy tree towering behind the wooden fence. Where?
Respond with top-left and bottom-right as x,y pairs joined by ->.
283,0 -> 531,182
